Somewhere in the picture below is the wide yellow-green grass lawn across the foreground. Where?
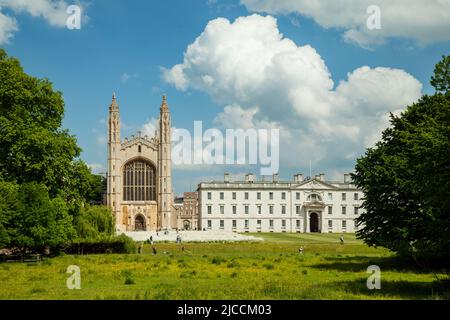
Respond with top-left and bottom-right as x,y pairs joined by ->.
0,233 -> 448,299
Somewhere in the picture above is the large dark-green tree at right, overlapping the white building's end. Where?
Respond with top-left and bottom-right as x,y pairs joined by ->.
353,57 -> 450,264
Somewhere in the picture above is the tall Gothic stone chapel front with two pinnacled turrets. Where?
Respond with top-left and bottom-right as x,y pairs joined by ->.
106,95 -> 177,231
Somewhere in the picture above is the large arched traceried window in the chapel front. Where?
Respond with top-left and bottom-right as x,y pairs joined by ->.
123,160 -> 156,201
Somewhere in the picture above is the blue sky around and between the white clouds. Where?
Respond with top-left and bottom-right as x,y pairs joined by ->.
0,0 -> 450,194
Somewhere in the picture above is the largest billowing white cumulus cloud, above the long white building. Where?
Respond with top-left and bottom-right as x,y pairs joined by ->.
163,14 -> 422,174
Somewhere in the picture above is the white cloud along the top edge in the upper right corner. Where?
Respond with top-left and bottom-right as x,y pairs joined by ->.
241,0 -> 450,47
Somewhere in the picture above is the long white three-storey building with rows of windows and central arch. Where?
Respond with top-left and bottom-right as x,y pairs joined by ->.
198,174 -> 363,232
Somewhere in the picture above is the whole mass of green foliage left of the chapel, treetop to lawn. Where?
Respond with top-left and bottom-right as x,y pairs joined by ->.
0,49 -> 109,250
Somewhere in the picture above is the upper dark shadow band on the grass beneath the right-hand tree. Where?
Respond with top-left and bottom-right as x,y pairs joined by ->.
311,256 -> 442,274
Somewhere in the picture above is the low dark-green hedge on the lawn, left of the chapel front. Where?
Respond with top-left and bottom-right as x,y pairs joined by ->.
64,234 -> 136,254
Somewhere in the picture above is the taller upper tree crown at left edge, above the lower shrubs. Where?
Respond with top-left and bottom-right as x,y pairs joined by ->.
0,49 -> 101,204
